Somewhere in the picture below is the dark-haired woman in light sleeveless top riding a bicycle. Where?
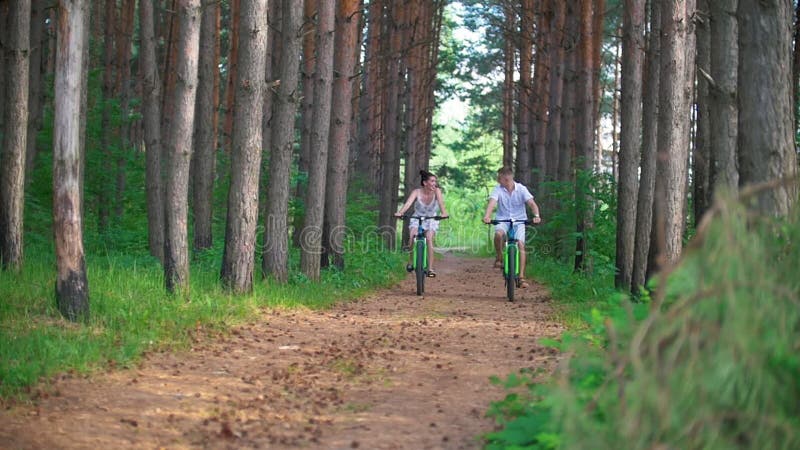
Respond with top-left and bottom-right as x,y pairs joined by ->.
394,170 -> 448,277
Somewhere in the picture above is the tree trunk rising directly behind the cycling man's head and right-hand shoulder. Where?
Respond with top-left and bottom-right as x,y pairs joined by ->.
514,0 -> 545,185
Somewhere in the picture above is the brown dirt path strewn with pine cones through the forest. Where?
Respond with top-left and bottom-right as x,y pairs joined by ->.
0,256 -> 562,450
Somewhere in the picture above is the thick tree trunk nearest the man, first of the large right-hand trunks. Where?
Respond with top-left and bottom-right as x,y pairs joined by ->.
614,0 -> 645,291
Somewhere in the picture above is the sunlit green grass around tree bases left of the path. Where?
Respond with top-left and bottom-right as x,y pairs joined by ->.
0,241 -> 404,397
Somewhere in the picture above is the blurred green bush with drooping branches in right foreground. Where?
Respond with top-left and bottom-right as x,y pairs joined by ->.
486,201 -> 800,449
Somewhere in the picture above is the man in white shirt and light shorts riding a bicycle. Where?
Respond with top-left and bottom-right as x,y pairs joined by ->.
483,167 -> 542,288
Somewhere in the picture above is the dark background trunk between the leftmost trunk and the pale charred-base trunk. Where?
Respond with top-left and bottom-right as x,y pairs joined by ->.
24,0 -> 46,184
